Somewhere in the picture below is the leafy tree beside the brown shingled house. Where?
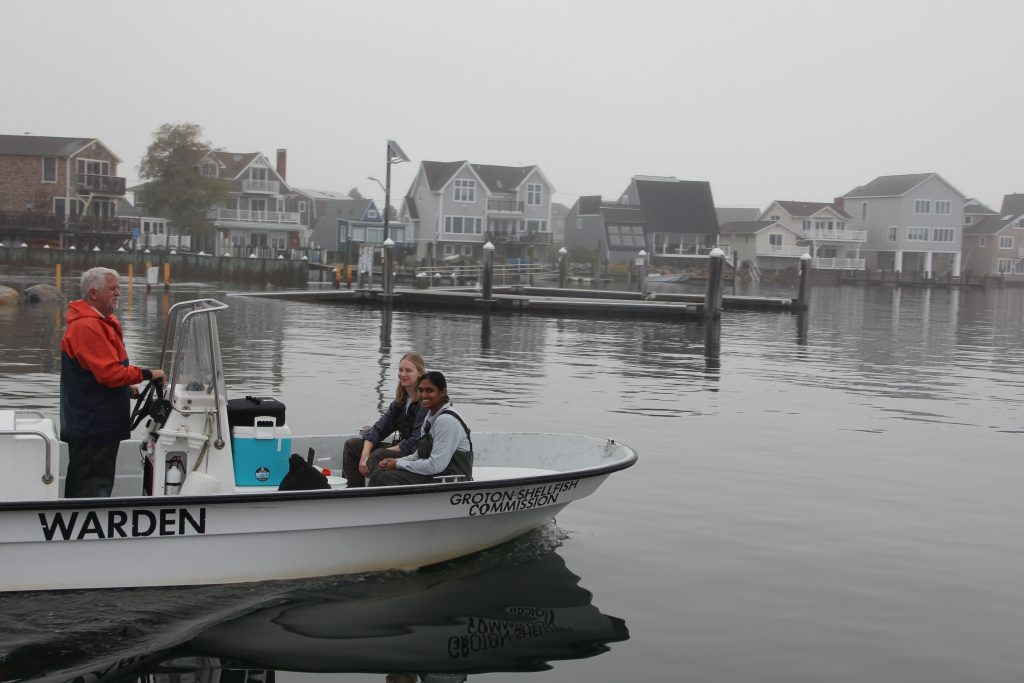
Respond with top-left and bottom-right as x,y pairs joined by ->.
138,123 -> 229,248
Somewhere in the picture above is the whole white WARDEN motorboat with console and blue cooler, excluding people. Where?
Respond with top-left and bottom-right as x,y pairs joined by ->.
0,299 -> 637,591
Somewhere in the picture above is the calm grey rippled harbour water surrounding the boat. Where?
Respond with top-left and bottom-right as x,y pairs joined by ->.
0,278 -> 1024,683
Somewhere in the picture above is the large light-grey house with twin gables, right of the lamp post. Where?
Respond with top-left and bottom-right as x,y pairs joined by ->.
398,161 -> 554,261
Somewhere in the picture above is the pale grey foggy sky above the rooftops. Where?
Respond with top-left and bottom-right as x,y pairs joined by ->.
0,0 -> 1024,208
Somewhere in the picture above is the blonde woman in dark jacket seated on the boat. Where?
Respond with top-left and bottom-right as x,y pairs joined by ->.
341,351 -> 427,486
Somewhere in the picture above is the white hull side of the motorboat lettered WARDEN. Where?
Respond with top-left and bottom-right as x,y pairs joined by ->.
6,436 -> 635,591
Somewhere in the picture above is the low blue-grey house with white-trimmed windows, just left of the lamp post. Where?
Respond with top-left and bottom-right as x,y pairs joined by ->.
310,199 -> 409,263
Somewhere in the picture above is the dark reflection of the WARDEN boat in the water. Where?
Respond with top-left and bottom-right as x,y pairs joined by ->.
0,526 -> 629,682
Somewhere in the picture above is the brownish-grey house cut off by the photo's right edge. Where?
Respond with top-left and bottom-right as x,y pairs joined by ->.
964,194 -> 1024,275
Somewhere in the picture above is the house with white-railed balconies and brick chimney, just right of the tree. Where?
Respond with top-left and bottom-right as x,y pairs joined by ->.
199,150 -> 309,258
